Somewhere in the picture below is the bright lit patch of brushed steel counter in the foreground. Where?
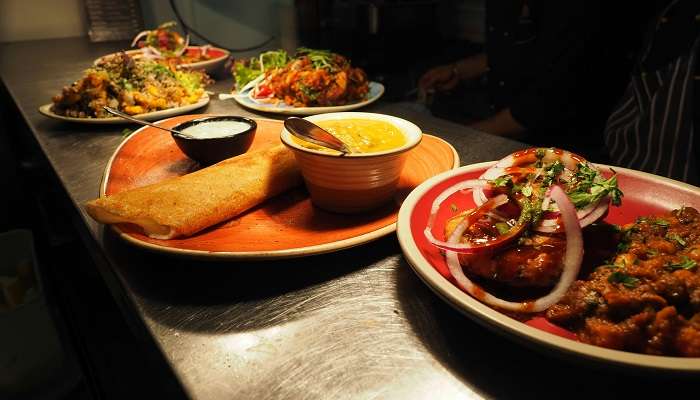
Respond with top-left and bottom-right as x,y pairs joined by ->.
149,256 -> 479,399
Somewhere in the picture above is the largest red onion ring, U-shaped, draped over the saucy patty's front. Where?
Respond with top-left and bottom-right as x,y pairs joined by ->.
445,186 -> 583,313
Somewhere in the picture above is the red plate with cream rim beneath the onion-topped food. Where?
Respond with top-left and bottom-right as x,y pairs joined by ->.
397,162 -> 700,374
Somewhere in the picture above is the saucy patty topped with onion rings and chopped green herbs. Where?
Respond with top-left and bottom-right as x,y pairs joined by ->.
425,148 -> 622,312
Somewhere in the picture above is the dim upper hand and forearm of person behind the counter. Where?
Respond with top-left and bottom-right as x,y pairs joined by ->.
418,53 -> 488,93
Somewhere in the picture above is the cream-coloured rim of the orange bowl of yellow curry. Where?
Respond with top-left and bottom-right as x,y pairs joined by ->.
280,111 -> 423,158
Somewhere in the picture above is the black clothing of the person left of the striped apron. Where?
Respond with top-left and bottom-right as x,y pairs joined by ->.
486,0 -> 641,161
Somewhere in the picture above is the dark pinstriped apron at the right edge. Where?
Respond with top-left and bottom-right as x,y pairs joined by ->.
605,0 -> 700,185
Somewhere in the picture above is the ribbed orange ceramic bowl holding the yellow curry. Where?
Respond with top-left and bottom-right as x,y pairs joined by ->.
281,112 -> 422,214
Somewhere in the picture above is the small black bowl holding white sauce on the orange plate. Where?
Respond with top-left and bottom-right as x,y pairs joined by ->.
171,115 -> 258,165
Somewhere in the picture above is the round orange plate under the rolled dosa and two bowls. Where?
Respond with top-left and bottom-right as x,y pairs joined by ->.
100,115 -> 459,259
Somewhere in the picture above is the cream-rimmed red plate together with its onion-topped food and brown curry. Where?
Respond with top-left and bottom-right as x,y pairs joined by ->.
397,153 -> 700,373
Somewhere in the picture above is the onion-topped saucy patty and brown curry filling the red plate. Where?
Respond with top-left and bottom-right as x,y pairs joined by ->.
425,149 -> 700,357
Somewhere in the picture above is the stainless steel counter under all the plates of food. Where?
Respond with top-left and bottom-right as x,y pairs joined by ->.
0,39 -> 687,399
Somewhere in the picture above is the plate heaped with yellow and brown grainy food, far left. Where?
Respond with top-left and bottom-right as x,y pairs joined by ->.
39,53 -> 210,124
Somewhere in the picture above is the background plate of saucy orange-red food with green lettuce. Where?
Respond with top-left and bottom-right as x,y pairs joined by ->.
225,47 -> 384,115
